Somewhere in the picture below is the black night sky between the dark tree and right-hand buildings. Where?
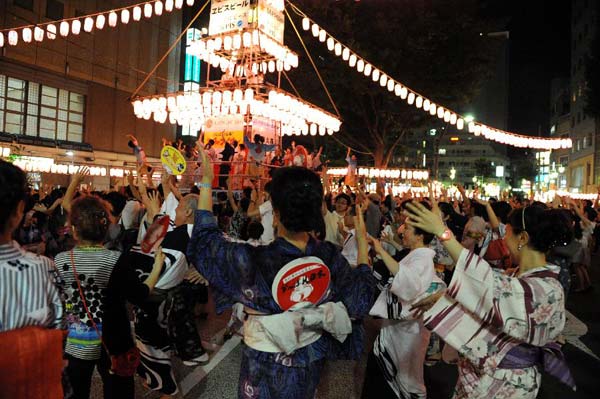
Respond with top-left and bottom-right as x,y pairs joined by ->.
483,0 -> 571,135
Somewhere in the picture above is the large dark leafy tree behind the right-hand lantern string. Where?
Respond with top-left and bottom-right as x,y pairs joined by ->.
284,0 -> 497,167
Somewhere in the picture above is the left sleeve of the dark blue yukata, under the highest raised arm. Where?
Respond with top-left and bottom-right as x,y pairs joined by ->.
187,210 -> 253,312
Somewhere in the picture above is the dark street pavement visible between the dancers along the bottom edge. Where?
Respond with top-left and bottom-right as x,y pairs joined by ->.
92,257 -> 600,399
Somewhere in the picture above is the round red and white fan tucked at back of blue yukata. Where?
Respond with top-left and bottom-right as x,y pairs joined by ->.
271,256 -> 331,310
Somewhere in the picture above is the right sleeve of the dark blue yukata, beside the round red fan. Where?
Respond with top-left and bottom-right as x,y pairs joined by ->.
333,252 -> 377,319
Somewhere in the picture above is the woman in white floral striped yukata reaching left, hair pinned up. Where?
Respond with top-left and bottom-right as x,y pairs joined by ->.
407,204 -> 575,399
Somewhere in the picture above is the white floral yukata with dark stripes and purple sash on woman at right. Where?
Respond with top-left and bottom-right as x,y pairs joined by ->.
424,249 -> 573,399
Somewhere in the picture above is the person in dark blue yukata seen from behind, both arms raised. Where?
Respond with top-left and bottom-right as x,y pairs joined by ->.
188,148 -> 375,399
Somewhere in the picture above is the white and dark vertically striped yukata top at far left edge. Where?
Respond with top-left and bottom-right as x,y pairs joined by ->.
0,241 -> 63,332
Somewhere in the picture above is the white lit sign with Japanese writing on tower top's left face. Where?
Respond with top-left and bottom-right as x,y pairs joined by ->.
208,0 -> 251,35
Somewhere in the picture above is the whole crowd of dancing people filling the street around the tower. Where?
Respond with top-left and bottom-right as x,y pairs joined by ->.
0,136 -> 600,398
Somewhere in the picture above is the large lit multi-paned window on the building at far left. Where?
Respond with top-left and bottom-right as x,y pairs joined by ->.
0,75 -> 85,142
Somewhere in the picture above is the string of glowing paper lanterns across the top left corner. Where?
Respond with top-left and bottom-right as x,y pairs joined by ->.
0,0 -> 194,48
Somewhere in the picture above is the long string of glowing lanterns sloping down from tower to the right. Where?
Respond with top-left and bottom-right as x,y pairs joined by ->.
292,11 -> 573,150
